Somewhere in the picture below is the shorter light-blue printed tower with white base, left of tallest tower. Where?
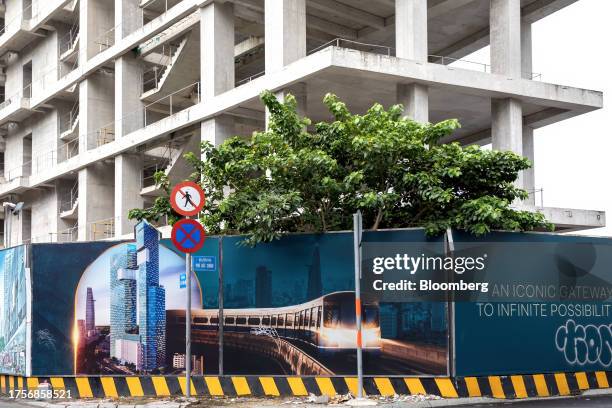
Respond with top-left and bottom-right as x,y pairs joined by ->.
110,244 -> 140,360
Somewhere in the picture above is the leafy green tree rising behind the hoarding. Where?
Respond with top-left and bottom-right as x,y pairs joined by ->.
129,92 -> 552,245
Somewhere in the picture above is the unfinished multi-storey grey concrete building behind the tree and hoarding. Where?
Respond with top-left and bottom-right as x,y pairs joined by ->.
0,0 -> 605,245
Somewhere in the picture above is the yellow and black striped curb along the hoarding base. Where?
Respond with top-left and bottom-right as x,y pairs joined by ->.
0,371 -> 612,398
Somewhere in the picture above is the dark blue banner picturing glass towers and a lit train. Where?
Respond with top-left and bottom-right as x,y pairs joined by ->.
26,223 -> 448,376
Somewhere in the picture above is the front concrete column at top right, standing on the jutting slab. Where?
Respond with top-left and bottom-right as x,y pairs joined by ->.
489,0 -> 521,78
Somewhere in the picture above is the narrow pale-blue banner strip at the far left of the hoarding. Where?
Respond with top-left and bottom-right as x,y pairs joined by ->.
0,246 -> 29,376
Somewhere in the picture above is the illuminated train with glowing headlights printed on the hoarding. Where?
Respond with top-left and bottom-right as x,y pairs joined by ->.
168,292 -> 381,351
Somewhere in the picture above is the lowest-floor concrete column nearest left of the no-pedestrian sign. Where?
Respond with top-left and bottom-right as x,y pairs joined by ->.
115,154 -> 144,237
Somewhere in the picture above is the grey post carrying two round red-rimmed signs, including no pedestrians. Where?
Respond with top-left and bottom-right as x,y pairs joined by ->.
170,181 -> 206,398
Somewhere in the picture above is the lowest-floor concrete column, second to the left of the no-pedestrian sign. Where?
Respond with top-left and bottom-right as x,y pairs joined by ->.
78,163 -> 115,241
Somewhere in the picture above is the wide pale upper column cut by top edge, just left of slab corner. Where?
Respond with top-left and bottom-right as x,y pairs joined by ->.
265,0 -> 306,74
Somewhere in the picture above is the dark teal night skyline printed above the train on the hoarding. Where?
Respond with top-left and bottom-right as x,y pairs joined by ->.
212,234 -> 354,309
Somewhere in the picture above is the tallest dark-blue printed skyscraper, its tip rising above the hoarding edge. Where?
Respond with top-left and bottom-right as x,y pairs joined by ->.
135,221 -> 166,371
